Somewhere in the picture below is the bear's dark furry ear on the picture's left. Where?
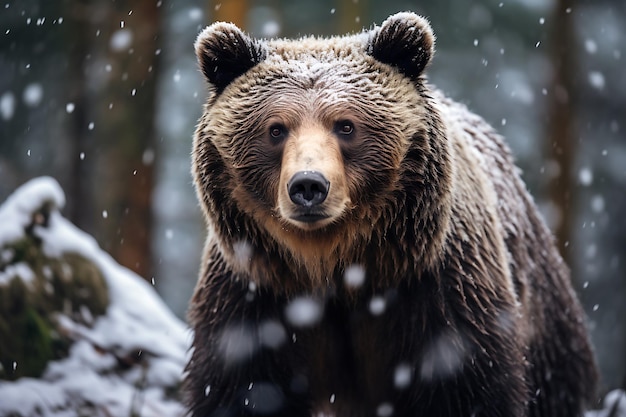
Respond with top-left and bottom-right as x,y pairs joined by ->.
194,22 -> 267,94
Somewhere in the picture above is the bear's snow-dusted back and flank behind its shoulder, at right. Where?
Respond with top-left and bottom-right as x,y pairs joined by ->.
433,89 -> 598,416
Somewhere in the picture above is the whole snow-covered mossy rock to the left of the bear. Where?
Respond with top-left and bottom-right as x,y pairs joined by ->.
0,178 -> 191,417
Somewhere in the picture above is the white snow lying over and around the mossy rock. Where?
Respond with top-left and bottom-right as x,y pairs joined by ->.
0,178 -> 191,417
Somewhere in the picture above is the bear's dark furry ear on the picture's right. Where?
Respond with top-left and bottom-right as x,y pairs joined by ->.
367,12 -> 435,78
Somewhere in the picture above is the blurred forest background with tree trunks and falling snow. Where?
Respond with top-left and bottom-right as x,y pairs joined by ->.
0,0 -> 626,394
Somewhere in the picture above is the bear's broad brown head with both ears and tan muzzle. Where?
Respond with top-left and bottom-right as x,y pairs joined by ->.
193,13 -> 449,286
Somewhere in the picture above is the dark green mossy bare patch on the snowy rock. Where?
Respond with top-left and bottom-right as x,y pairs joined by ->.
0,235 -> 109,380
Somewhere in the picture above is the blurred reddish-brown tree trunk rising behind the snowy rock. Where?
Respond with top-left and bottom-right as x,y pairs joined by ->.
91,0 -> 161,279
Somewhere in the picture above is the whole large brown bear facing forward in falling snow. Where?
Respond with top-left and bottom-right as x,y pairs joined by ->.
185,13 -> 596,417
